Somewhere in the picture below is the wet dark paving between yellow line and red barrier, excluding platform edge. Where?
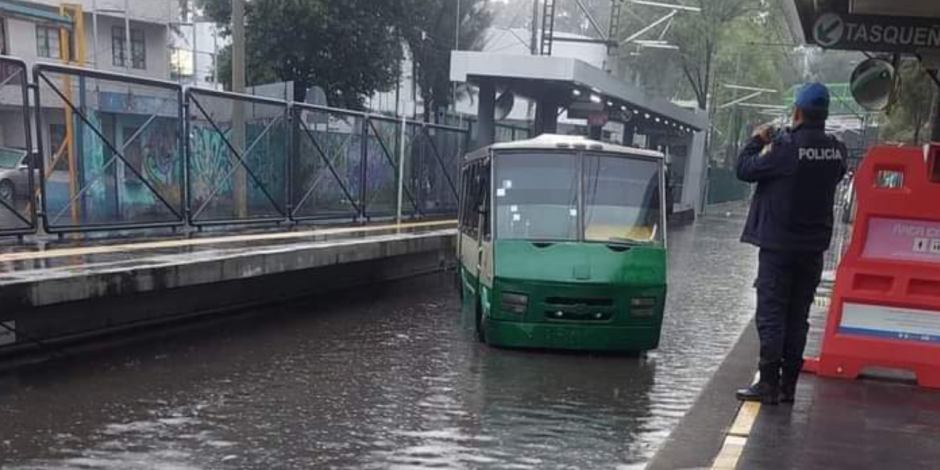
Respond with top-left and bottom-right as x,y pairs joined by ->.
736,375 -> 940,470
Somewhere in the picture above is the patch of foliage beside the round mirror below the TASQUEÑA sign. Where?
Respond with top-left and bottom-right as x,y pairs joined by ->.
881,60 -> 936,145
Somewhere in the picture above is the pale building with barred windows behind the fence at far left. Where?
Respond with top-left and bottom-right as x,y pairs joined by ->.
0,0 -> 180,223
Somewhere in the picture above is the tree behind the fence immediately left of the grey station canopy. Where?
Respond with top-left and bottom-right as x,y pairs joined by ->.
400,0 -> 492,121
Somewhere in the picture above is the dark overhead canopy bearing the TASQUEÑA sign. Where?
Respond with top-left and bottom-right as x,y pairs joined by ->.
784,0 -> 940,53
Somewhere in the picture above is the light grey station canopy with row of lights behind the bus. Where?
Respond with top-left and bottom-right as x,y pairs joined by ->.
450,51 -> 708,132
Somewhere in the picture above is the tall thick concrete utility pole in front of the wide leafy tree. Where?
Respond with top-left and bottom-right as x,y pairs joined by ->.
232,0 -> 248,219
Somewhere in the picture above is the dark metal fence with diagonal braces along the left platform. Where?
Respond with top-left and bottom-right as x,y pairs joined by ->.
0,57 -> 496,235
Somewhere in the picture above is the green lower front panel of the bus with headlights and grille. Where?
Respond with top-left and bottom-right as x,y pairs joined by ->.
479,240 -> 666,351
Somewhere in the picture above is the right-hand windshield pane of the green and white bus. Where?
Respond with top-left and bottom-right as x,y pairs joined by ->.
584,155 -> 662,243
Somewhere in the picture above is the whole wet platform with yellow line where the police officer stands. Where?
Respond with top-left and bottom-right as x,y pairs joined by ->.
647,297 -> 940,470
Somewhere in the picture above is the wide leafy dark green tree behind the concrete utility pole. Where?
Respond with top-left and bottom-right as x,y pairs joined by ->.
199,0 -> 403,109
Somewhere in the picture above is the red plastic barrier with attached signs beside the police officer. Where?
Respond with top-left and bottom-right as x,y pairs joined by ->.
806,145 -> 940,388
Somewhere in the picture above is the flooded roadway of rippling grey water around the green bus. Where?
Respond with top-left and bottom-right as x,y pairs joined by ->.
0,214 -> 756,470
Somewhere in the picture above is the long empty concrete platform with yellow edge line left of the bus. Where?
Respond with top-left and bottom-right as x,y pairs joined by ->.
0,221 -> 456,357
